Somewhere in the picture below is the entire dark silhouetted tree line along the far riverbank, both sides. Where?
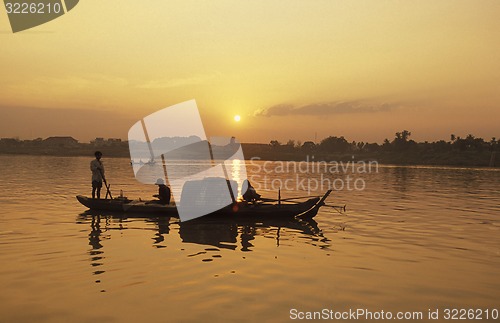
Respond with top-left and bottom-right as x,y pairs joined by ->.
0,130 -> 500,167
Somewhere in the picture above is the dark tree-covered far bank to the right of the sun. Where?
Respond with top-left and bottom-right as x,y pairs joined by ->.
244,130 -> 500,167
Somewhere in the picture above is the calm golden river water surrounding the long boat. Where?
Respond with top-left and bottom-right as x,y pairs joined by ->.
0,156 -> 500,322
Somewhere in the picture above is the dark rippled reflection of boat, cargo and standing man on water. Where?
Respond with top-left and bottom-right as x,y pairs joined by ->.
76,211 -> 330,292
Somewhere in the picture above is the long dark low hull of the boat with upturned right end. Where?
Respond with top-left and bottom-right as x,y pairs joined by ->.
76,190 -> 331,218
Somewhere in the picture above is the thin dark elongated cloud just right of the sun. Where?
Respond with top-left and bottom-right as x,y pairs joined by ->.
255,101 -> 398,117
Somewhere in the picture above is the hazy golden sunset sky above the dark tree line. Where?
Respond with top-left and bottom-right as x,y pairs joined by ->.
0,0 -> 500,143
